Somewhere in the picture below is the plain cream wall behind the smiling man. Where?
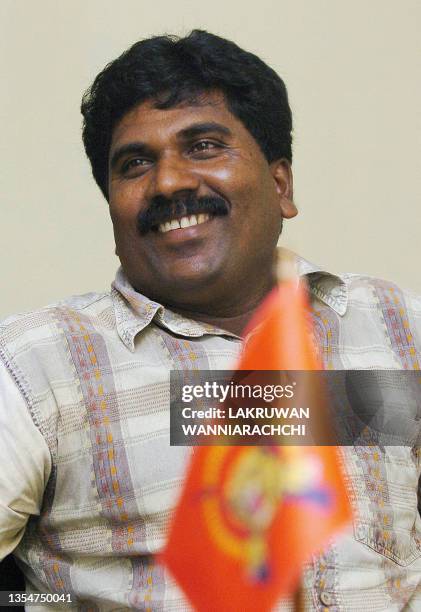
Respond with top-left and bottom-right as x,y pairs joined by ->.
0,0 -> 421,317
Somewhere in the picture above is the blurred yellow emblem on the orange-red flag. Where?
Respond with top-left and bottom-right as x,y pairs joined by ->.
200,446 -> 330,583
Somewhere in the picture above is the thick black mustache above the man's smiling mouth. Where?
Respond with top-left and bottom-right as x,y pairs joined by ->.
137,194 -> 229,235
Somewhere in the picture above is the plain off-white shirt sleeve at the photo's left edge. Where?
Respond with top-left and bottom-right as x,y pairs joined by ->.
0,363 -> 51,560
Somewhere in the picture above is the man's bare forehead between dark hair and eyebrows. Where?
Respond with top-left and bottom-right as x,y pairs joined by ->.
110,93 -> 257,153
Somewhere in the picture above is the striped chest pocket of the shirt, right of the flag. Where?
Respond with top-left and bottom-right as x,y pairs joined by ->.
346,446 -> 421,566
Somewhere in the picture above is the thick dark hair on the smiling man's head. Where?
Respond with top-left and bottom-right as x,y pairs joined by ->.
81,30 -> 292,197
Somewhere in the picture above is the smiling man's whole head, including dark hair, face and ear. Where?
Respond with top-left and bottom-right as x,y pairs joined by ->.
82,32 -> 297,332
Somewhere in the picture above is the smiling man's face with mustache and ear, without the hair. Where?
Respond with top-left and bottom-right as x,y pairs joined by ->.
109,93 -> 296,314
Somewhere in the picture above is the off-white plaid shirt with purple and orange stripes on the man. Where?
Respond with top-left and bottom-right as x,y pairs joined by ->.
0,260 -> 421,612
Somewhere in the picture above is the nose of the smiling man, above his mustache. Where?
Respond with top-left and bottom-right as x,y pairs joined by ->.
149,156 -> 200,199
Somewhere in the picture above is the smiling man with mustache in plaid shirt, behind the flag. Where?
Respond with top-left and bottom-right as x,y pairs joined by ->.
0,31 -> 421,611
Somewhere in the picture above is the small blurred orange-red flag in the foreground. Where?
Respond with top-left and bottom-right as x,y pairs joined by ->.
161,281 -> 350,612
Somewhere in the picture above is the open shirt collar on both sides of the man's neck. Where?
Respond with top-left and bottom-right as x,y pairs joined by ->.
111,255 -> 348,352
